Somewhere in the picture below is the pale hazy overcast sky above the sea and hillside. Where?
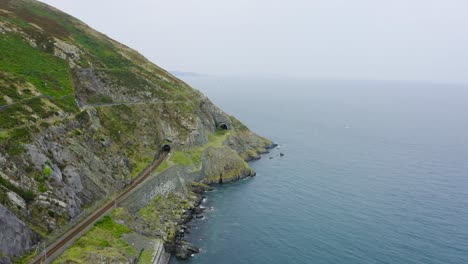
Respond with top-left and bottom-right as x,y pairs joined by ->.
43,0 -> 468,82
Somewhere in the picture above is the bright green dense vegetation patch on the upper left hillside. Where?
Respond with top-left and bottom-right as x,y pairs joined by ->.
0,34 -> 73,97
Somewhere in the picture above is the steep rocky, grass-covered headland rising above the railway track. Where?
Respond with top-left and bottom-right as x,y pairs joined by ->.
0,0 -> 271,262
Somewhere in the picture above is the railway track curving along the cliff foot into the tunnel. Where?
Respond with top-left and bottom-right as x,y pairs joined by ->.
31,151 -> 169,264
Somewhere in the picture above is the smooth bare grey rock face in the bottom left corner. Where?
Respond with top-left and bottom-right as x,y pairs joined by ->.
0,204 -> 39,263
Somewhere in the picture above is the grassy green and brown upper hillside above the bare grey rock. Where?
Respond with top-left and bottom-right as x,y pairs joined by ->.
0,0 -> 199,159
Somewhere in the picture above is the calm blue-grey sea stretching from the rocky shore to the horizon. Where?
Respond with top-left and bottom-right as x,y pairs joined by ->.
173,77 -> 468,264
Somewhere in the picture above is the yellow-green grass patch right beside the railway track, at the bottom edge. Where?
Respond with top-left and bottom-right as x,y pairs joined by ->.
54,216 -> 137,263
